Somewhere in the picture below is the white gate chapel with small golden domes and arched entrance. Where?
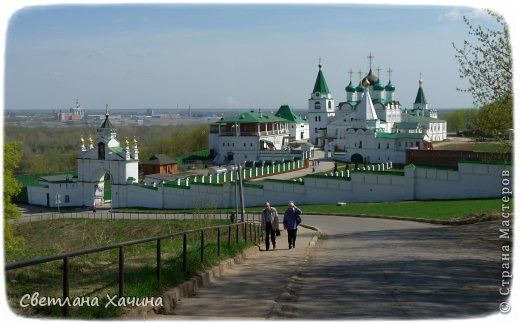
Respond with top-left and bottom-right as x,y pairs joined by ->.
27,105 -> 139,207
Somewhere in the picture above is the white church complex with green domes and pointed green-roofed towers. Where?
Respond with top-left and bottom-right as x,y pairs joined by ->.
308,55 -> 447,164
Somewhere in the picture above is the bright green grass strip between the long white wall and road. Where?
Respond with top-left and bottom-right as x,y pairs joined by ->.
118,198 -> 501,220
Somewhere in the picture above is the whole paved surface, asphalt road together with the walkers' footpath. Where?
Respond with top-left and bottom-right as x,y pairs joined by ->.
153,215 -> 501,319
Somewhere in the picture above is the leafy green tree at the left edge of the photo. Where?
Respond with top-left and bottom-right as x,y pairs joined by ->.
4,141 -> 24,252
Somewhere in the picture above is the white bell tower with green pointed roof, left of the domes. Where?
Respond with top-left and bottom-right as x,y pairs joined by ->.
308,60 -> 335,147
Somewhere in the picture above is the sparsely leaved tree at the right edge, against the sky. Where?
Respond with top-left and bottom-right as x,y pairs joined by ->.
453,10 -> 513,138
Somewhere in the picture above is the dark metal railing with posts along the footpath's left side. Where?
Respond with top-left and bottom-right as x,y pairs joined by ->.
5,221 -> 263,317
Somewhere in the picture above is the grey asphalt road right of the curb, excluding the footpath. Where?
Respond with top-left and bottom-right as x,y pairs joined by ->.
281,216 -> 502,319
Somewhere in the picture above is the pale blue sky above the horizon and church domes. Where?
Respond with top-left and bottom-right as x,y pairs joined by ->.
4,1 -> 507,110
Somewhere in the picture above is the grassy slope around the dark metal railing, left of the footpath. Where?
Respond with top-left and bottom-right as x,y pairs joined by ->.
6,218 -> 253,319
